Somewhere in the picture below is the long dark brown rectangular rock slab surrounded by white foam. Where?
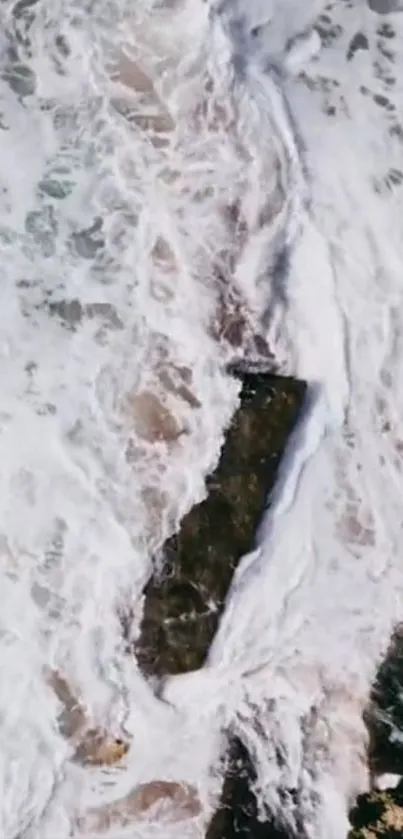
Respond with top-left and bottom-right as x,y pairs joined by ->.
136,373 -> 305,676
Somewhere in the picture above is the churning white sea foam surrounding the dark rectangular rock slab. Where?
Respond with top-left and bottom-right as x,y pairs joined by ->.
0,0 -> 403,839
